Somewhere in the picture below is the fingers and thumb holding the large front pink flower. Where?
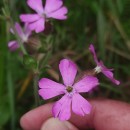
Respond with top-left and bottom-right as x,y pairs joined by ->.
20,99 -> 130,130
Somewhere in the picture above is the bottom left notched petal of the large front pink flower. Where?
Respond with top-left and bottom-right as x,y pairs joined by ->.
52,95 -> 71,120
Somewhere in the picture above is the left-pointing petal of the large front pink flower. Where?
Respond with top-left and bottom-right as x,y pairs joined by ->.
39,78 -> 65,99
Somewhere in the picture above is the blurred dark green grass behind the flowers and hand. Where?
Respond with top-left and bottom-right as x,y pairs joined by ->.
0,0 -> 130,130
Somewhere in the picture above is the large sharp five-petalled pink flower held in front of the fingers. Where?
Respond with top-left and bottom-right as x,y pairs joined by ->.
39,59 -> 99,120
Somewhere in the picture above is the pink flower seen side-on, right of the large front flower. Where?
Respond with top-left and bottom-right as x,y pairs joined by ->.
89,44 -> 120,85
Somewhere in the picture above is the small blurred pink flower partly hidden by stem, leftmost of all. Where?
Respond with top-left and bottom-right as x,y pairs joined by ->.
8,23 -> 31,51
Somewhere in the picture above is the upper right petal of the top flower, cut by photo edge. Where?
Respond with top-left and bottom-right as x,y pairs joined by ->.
45,0 -> 63,13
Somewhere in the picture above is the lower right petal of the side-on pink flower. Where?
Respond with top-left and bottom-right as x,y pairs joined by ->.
102,70 -> 120,85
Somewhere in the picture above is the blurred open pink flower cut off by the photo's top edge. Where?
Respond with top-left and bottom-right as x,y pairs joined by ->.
20,0 -> 68,33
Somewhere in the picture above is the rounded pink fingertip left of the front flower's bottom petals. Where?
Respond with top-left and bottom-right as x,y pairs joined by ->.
20,104 -> 52,130
